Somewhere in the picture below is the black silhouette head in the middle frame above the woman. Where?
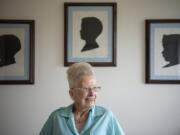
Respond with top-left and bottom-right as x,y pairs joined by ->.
80,17 -> 103,52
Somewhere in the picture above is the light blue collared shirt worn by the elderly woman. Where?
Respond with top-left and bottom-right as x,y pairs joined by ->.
39,105 -> 125,135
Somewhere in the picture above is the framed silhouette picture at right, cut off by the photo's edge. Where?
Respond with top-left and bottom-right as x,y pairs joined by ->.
145,19 -> 180,84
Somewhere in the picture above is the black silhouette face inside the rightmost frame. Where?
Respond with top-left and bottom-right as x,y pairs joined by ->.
162,34 -> 180,68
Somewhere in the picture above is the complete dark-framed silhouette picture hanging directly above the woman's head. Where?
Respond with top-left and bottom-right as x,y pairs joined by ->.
64,2 -> 117,66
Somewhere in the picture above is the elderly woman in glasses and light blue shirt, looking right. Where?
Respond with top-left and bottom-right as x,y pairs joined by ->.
40,63 -> 125,135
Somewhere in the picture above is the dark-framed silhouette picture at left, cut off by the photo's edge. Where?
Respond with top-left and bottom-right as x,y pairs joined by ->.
0,19 -> 35,84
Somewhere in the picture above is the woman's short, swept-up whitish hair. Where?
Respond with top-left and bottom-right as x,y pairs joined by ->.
67,62 -> 94,88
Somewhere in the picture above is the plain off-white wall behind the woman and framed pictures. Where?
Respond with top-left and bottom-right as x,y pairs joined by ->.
0,0 -> 180,135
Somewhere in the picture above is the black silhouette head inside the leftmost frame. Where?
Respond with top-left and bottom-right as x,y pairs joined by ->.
0,35 -> 21,67
